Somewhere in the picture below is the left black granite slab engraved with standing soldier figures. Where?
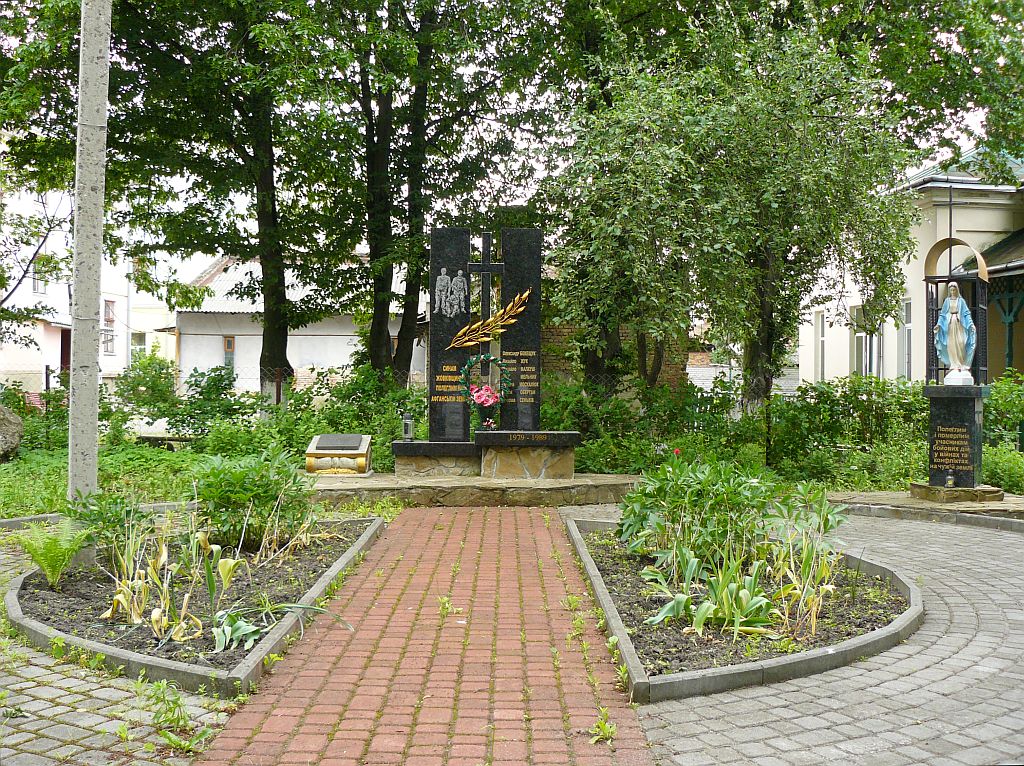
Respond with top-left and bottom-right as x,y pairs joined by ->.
428,228 -> 475,441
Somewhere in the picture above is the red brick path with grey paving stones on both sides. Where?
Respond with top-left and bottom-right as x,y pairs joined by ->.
0,506 -> 1024,766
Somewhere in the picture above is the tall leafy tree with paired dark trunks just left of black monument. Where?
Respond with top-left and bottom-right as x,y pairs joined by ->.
327,0 -> 546,377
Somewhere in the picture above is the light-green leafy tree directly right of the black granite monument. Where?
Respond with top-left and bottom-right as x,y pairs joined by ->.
547,77 -> 694,385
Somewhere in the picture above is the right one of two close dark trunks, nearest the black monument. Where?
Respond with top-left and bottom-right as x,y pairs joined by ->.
393,9 -> 437,380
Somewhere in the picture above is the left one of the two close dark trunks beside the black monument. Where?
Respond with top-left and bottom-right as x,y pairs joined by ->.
359,45 -> 394,371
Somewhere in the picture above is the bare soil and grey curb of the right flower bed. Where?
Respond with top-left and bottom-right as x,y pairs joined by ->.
568,520 -> 924,703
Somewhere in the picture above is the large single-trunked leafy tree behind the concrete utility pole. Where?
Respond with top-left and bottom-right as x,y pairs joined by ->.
0,0 -> 357,385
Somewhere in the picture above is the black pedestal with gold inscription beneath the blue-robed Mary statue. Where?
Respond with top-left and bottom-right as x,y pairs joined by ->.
910,385 -> 1001,502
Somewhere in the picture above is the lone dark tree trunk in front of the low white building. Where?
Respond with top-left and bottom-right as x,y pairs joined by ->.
250,90 -> 294,396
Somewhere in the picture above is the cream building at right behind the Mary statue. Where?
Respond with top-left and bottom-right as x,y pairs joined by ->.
799,153 -> 1024,381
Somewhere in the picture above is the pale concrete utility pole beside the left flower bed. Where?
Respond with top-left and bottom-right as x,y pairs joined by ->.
68,0 -> 111,499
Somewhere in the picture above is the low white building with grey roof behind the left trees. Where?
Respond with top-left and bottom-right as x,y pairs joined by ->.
174,258 -> 426,391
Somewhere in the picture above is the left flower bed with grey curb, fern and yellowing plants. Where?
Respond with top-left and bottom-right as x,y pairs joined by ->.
6,450 -> 383,694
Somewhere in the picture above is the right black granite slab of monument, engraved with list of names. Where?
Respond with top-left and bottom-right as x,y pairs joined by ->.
501,228 -> 544,431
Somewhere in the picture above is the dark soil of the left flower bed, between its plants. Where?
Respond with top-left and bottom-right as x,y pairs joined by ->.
18,519 -> 370,670
